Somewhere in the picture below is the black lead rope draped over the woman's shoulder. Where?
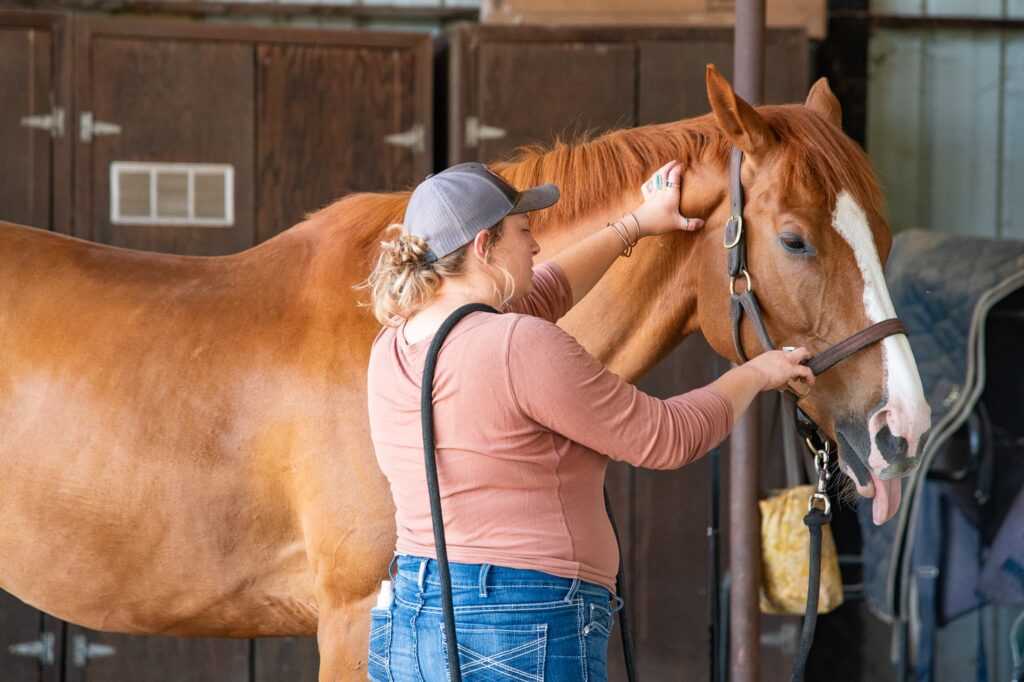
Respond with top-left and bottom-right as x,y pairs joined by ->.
420,303 -> 637,682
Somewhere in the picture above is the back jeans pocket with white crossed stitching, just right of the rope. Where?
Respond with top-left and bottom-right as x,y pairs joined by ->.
438,623 -> 548,682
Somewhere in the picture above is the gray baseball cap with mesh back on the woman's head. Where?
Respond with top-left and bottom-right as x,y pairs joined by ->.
403,162 -> 560,263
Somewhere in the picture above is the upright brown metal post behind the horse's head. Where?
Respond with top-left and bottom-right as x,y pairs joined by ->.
729,0 -> 765,682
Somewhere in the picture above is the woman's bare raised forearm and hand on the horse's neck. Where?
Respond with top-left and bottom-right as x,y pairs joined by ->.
551,161 -> 703,305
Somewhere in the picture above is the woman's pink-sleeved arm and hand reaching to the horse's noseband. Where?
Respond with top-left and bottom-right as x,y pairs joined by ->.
504,316 -> 810,469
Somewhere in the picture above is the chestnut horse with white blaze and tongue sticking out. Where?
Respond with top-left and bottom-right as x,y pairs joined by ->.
0,68 -> 929,680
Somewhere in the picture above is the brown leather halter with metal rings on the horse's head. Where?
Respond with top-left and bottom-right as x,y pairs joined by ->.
724,147 -> 906,445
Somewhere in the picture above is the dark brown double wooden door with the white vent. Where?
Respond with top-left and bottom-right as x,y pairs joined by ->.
76,19 -> 432,255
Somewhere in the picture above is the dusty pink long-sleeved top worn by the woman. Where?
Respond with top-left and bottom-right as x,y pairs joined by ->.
368,262 -> 732,592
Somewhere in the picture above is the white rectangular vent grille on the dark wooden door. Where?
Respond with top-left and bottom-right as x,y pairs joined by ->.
111,161 -> 234,227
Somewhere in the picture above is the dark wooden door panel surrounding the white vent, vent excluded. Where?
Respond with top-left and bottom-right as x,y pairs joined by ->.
78,36 -> 255,255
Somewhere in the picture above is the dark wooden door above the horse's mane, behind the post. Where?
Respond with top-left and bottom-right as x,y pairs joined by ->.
449,25 -> 808,164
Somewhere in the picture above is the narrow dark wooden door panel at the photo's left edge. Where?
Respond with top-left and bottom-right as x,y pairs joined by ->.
0,25 -> 53,227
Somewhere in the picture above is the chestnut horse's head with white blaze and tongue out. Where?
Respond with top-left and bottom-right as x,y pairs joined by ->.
700,66 -> 931,523
